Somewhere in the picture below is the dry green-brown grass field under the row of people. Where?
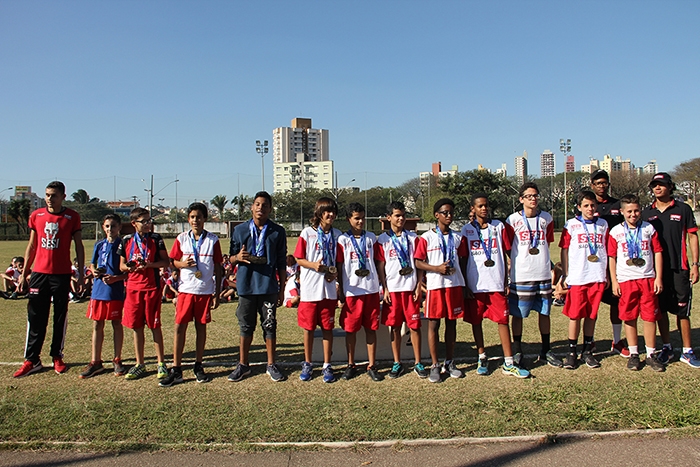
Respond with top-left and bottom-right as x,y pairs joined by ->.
0,240 -> 700,449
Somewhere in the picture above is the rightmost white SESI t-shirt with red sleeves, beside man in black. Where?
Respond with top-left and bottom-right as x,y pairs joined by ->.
608,221 -> 663,282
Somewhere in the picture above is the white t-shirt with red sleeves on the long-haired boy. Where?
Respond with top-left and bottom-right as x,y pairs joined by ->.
294,227 -> 342,302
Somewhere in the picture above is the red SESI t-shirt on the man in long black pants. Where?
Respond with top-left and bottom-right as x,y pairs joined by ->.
29,208 -> 81,274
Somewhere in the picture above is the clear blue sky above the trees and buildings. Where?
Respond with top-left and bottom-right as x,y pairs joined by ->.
0,0 -> 700,205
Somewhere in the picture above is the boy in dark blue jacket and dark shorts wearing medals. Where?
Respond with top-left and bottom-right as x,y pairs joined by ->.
228,191 -> 287,382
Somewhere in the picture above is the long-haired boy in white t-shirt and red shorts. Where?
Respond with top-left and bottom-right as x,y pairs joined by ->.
294,197 -> 342,383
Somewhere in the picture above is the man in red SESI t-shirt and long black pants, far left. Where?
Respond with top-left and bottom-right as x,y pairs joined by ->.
14,181 -> 85,378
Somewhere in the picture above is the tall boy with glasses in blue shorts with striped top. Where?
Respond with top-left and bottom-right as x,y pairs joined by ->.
506,182 -> 562,368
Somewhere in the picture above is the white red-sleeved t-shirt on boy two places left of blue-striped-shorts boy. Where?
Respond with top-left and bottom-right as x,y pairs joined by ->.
413,229 -> 467,290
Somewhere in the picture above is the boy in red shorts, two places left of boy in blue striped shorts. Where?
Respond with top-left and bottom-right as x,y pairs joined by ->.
414,198 -> 467,383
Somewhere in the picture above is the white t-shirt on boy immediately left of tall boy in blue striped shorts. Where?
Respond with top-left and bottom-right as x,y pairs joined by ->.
462,220 -> 513,293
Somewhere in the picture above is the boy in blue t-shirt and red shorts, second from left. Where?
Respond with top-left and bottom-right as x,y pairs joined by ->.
80,214 -> 126,378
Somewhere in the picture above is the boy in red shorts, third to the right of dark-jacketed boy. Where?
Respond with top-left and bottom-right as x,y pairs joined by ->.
377,201 -> 428,379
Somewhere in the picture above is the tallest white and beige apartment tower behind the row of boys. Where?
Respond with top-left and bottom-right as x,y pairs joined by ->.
272,118 -> 333,193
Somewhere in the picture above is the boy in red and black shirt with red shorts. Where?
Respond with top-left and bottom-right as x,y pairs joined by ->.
118,208 -> 170,380
